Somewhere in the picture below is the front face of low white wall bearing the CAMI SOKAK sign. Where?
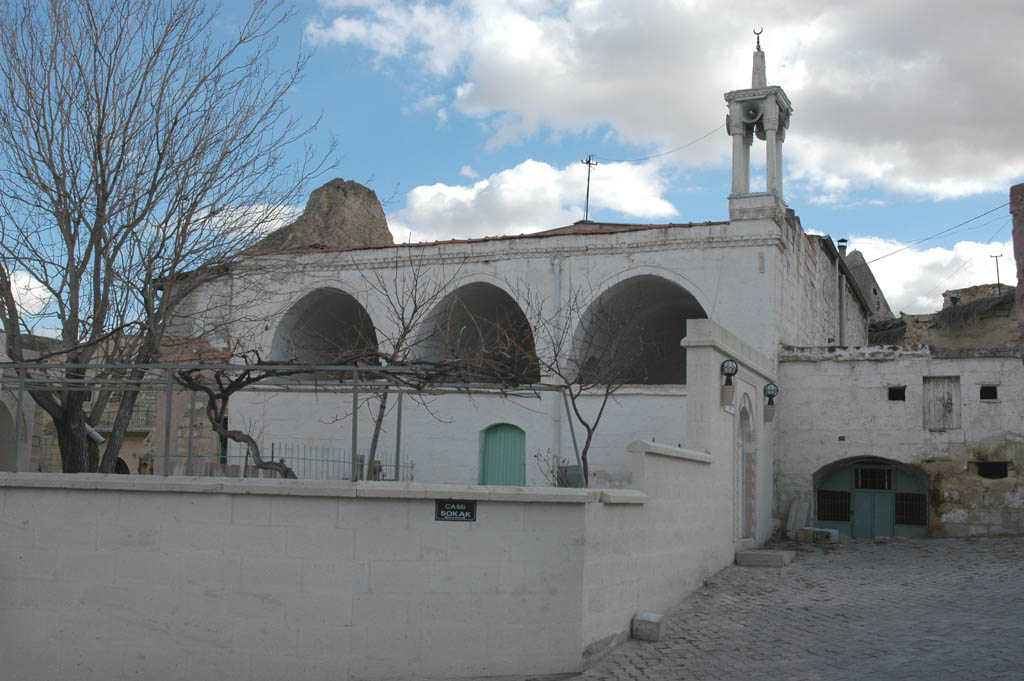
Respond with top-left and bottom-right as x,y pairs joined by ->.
0,473 -> 593,681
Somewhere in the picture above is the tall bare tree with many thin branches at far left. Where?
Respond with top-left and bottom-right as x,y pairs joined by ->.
0,0 -> 333,472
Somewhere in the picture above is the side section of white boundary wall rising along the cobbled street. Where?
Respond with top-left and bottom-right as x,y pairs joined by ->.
583,442 -> 733,662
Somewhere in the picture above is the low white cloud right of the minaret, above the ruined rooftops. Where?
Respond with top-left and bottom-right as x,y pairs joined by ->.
849,237 -> 1017,314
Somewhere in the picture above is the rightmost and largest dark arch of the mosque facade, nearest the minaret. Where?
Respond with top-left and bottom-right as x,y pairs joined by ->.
573,274 -> 708,385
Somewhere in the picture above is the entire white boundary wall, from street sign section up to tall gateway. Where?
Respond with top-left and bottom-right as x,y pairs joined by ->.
0,320 -> 774,681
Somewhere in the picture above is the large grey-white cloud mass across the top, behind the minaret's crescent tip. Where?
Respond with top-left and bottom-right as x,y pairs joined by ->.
308,0 -> 1024,203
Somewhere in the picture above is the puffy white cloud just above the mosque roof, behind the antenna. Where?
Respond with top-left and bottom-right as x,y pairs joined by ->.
388,160 -> 677,241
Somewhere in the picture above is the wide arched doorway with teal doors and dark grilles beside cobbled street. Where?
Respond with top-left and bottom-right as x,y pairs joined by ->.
814,457 -> 929,537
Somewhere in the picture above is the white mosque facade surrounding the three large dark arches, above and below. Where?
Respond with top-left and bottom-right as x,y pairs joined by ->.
178,206 -> 864,485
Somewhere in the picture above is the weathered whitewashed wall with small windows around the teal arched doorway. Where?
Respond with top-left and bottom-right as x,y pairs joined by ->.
775,347 -> 1024,536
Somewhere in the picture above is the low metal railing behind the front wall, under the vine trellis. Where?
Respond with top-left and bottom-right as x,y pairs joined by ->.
139,441 -> 416,482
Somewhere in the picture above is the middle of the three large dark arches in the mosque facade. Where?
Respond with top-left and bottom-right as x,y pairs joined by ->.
418,282 -> 541,385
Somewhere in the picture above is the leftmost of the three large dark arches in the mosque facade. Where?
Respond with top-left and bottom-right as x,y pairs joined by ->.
270,289 -> 377,365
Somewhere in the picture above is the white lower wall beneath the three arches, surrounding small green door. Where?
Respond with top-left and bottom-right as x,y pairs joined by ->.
231,386 -> 686,486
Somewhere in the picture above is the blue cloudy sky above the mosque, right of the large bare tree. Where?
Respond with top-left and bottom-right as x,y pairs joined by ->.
253,0 -> 1024,312
